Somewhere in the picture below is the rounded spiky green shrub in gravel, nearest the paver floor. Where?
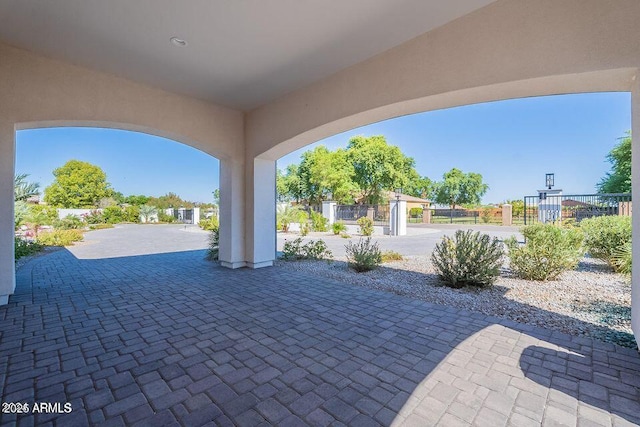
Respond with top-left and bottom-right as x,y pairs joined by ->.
431,230 -> 504,288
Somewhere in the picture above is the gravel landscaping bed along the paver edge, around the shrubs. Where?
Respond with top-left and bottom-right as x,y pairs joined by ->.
276,256 -> 637,348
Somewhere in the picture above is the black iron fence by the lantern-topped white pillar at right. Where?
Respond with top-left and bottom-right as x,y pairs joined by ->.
524,193 -> 631,225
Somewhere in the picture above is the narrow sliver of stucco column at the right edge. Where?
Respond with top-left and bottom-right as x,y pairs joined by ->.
631,74 -> 640,343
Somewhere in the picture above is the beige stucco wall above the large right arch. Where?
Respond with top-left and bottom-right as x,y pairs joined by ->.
246,0 -> 640,159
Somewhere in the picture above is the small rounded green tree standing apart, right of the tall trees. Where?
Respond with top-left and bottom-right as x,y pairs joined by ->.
434,168 -> 489,209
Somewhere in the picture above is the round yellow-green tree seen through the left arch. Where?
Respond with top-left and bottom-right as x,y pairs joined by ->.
44,160 -> 113,208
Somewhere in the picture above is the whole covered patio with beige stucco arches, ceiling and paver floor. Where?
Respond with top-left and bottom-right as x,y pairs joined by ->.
0,0 -> 640,426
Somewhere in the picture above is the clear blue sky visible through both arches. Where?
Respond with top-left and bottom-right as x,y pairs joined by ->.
16,92 -> 631,203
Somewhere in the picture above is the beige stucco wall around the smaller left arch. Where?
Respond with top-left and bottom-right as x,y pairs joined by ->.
0,44 -> 244,303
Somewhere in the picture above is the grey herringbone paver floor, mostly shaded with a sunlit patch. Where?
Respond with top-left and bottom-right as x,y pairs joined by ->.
0,227 -> 640,427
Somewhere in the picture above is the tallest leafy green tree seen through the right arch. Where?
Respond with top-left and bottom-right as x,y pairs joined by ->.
347,135 -> 415,204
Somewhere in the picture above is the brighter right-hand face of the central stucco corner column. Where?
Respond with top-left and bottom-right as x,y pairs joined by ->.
245,158 -> 276,268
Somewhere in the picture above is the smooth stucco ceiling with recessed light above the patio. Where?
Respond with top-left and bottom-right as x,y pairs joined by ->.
0,0 -> 493,110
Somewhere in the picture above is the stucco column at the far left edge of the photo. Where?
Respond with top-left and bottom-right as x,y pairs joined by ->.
0,123 -> 16,305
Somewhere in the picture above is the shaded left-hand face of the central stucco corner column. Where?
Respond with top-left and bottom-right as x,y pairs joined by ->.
218,159 -> 246,268
